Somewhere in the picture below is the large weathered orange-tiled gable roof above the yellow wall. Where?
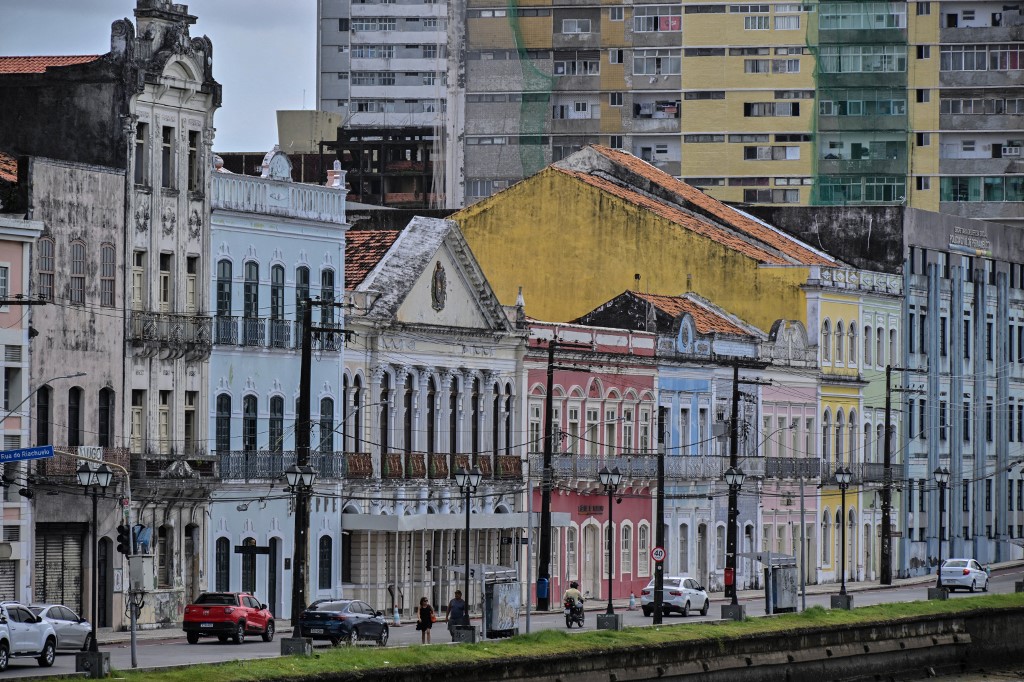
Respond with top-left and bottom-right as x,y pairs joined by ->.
555,144 -> 838,265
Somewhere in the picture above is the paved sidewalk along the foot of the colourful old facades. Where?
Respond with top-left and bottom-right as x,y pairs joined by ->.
96,561 -> 1024,645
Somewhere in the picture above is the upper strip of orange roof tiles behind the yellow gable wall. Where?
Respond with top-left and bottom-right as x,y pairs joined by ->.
591,144 -> 836,265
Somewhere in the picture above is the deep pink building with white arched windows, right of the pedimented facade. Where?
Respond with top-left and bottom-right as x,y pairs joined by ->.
524,323 -> 657,605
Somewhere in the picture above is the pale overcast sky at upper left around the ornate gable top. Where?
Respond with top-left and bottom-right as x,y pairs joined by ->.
0,0 -> 316,152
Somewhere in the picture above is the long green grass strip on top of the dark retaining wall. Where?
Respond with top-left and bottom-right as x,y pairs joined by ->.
116,593 -> 1024,682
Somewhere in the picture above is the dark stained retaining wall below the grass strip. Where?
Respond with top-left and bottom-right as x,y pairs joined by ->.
307,608 -> 1024,682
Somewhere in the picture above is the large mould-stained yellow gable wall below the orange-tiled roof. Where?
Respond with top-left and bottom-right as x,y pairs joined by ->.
453,169 -> 807,329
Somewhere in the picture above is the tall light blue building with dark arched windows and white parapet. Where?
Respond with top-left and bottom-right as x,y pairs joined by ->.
205,146 -> 348,617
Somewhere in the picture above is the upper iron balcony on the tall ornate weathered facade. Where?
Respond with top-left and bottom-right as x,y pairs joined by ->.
128,310 -> 213,358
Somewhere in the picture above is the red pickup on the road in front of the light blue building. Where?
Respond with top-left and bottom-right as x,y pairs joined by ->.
181,592 -> 274,644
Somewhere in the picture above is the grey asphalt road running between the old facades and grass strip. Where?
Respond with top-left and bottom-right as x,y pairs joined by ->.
8,569 -> 1022,680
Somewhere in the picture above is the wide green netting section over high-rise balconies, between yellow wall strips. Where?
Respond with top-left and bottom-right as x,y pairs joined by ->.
807,2 -> 912,205
